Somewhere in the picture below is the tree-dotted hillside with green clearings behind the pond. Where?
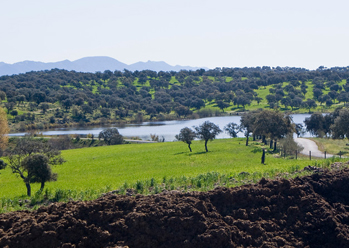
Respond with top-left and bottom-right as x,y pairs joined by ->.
0,67 -> 349,131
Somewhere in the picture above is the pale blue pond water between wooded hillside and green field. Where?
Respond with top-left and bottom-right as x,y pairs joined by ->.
9,114 -> 311,141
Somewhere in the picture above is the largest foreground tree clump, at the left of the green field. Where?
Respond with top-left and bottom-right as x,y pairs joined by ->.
7,137 -> 65,196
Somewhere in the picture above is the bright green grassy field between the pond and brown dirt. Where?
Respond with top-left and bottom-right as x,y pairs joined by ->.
0,138 -> 326,198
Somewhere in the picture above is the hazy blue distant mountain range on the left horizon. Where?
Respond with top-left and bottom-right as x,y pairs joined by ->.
0,56 -> 207,76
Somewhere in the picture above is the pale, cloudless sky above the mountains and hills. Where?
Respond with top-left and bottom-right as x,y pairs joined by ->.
0,0 -> 349,69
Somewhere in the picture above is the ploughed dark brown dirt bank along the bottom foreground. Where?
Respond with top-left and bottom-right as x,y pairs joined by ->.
0,169 -> 349,248
